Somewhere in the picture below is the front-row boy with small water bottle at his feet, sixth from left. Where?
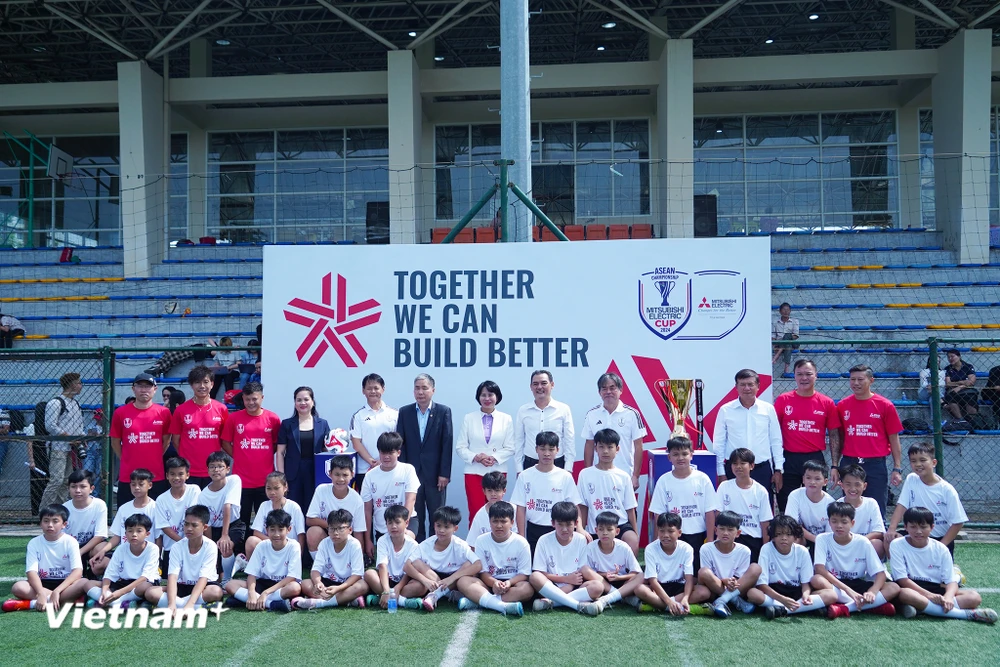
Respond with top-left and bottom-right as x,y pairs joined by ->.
365,505 -> 418,609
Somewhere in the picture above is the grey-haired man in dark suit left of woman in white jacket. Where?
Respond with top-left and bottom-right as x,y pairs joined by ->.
396,373 -> 455,542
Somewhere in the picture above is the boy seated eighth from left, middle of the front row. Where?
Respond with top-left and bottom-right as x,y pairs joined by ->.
457,500 -> 535,616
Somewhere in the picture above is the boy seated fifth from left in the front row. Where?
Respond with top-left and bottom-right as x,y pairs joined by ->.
292,510 -> 368,609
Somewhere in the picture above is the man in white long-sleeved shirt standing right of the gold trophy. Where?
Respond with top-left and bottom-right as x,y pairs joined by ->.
712,368 -> 785,505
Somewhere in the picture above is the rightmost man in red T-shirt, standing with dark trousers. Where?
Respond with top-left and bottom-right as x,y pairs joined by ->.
830,364 -> 903,516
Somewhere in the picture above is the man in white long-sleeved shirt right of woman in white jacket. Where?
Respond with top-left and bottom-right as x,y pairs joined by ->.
514,370 -> 576,474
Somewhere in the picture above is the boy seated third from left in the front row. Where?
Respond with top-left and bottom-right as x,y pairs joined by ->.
146,505 -> 224,611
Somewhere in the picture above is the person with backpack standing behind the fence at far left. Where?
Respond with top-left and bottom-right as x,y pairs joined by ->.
39,373 -> 84,507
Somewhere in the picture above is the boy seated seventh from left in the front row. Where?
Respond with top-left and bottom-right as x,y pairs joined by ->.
406,506 -> 482,611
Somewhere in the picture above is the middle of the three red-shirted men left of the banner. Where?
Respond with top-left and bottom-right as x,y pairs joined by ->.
170,366 -> 229,489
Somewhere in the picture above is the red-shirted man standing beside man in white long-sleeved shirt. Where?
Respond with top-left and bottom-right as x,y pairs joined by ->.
774,359 -> 840,512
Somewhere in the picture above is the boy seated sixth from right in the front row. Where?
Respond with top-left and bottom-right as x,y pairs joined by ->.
583,512 -> 642,616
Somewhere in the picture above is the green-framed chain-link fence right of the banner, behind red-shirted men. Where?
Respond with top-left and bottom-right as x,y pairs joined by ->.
774,338 -> 1000,524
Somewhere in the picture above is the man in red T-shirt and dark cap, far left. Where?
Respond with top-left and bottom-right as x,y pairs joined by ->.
111,373 -> 170,507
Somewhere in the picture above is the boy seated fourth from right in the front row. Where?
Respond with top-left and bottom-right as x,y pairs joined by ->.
698,511 -> 760,618
